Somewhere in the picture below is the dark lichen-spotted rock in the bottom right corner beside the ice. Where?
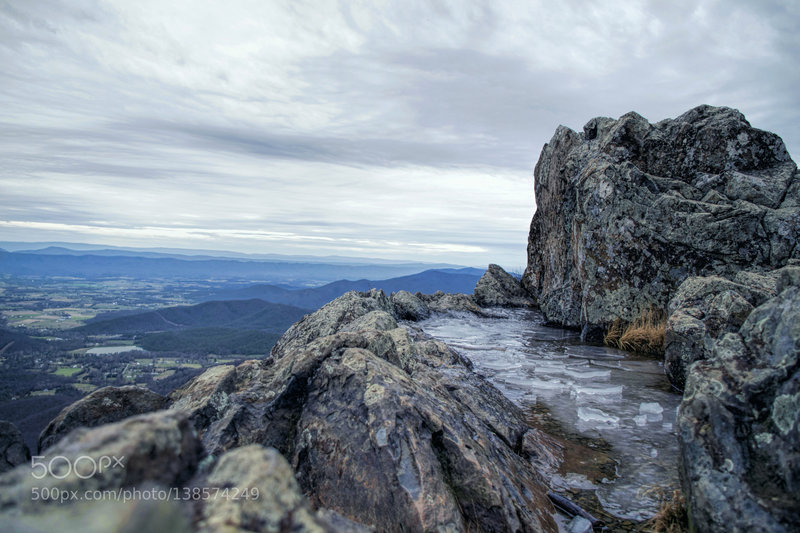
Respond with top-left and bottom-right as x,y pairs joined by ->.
677,279 -> 800,532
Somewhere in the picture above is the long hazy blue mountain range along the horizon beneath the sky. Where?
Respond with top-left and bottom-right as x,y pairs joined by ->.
0,243 -> 482,287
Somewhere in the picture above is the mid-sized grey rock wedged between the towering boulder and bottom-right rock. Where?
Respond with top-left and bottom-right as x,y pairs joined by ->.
664,266 -> 800,390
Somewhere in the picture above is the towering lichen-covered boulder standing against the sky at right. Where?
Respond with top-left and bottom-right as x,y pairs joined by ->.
522,106 -> 800,327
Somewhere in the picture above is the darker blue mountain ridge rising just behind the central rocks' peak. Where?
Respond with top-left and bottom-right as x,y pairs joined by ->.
204,268 -> 483,309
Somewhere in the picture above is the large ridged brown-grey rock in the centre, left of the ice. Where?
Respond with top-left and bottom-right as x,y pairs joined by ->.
173,291 -> 555,531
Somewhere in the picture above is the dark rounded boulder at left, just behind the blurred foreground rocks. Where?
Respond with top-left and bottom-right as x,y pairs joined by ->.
39,385 -> 167,452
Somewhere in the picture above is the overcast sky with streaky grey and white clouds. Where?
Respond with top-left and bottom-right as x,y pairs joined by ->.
0,0 -> 800,270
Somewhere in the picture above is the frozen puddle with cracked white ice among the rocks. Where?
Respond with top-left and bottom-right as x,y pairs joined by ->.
417,310 -> 680,520
